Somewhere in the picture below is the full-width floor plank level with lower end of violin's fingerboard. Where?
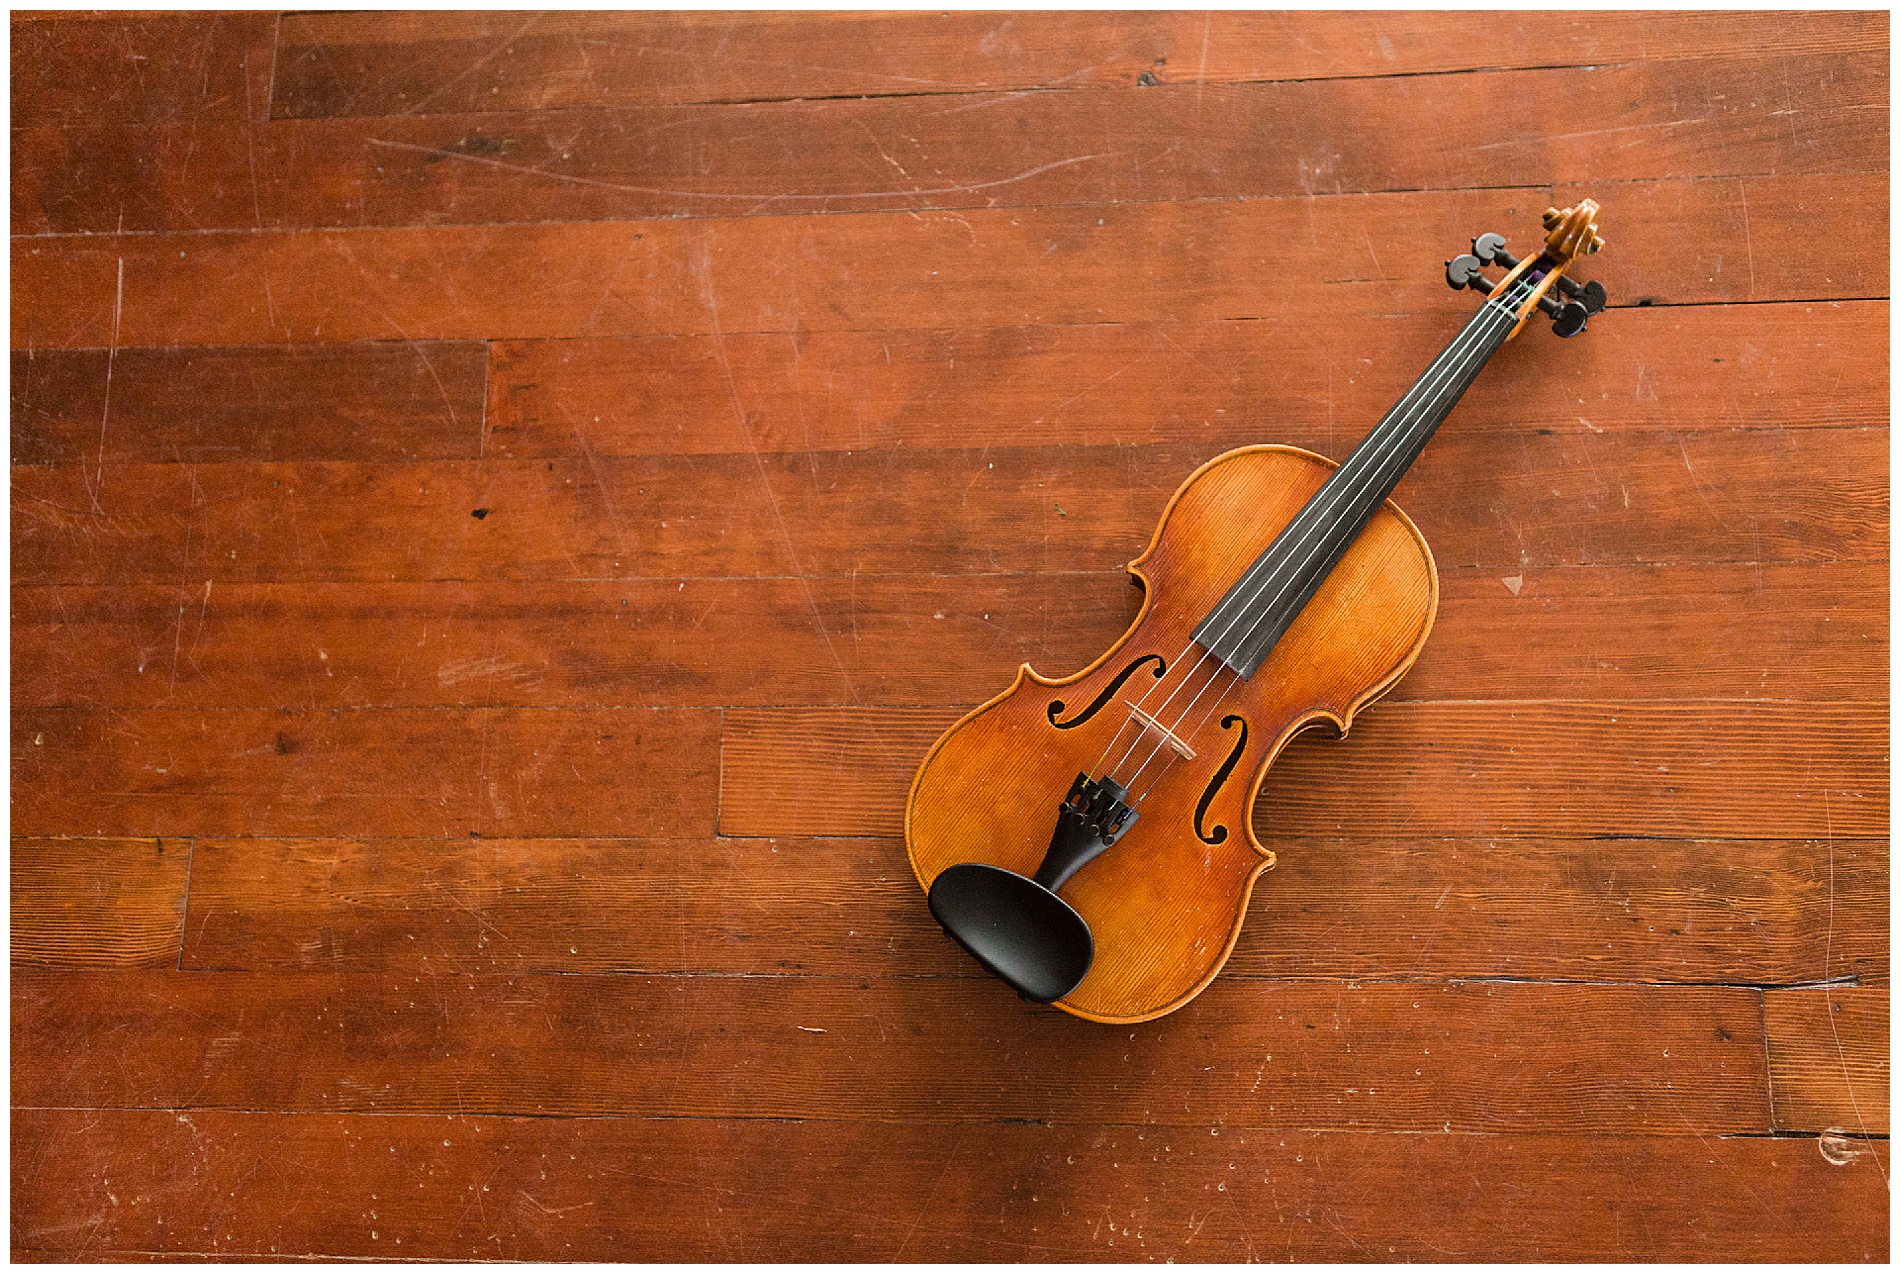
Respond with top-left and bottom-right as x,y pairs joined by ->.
11,562 -> 1889,708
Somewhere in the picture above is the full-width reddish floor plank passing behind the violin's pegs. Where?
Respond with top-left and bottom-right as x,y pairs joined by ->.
11,175 -> 1887,347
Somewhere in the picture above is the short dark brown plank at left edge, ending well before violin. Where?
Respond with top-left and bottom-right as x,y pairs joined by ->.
11,342 -> 488,473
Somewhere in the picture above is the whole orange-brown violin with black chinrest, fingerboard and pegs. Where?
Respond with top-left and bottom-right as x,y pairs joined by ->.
904,199 -> 1606,1023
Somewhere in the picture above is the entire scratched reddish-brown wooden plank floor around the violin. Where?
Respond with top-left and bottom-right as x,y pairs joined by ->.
11,11 -> 1891,1261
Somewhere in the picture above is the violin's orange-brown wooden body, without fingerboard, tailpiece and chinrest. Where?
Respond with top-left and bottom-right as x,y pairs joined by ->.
904,446 -> 1438,1021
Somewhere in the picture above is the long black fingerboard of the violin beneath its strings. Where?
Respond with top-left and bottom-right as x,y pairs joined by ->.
1193,298 -> 1516,678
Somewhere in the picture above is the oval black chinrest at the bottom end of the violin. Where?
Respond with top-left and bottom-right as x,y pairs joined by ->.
929,862 -> 1094,1004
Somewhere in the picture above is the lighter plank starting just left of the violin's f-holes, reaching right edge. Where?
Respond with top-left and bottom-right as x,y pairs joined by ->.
720,703 -> 1889,839
